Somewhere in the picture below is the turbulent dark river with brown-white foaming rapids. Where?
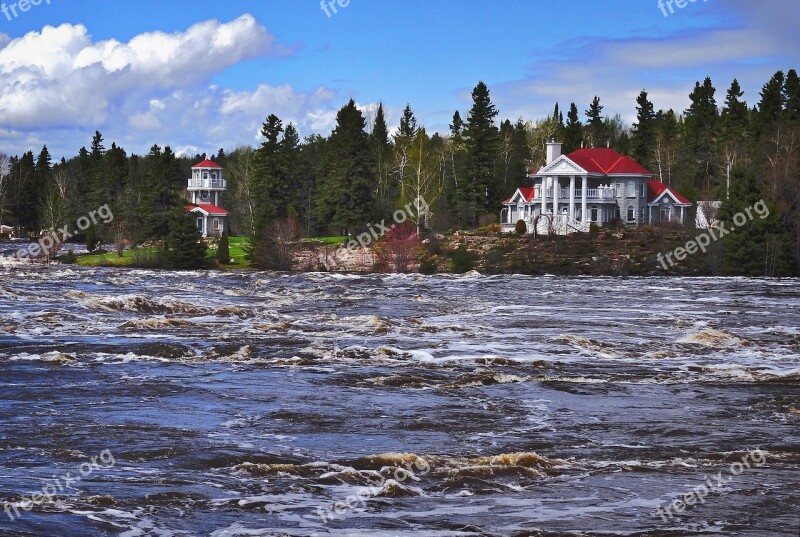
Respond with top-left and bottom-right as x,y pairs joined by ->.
0,258 -> 800,537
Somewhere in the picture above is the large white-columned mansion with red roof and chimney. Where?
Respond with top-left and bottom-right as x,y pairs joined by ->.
500,141 -> 692,235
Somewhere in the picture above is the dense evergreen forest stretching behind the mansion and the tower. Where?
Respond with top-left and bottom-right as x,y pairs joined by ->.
0,69 -> 800,275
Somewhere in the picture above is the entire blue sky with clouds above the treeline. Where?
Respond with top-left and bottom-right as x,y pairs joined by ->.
0,0 -> 800,158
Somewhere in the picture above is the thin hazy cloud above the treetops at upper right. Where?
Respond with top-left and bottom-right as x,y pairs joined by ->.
492,0 -> 800,124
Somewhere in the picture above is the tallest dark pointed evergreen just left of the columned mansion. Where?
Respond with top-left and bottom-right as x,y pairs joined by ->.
457,82 -> 504,226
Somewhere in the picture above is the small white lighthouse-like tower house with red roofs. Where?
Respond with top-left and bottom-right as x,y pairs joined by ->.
186,159 -> 228,237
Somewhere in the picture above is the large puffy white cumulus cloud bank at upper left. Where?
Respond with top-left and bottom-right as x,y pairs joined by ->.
0,15 -> 346,155
